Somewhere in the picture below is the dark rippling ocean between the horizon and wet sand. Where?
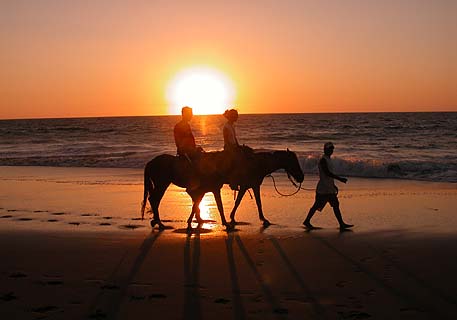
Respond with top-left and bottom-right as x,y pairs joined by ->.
0,112 -> 457,183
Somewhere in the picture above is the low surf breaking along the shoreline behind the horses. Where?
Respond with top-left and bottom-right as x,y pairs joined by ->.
0,150 -> 457,182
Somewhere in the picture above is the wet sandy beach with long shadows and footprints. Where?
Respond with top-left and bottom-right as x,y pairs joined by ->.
0,167 -> 457,319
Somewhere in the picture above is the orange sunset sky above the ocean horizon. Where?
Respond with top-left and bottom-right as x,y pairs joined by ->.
0,0 -> 457,119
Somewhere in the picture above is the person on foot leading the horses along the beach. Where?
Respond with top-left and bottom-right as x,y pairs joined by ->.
303,142 -> 354,230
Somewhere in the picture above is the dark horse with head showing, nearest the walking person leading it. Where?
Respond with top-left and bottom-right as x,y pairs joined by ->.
230,149 -> 304,226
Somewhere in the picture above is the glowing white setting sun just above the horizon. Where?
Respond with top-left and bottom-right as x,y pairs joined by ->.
166,66 -> 235,114
